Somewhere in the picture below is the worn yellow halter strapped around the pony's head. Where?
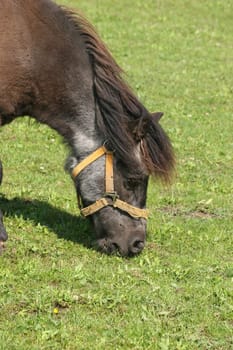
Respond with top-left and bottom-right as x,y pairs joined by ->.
72,146 -> 149,219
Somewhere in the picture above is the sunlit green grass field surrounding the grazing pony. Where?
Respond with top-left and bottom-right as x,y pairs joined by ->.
0,0 -> 233,350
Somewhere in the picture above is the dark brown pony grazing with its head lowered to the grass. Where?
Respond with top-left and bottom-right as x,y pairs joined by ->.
0,0 -> 174,255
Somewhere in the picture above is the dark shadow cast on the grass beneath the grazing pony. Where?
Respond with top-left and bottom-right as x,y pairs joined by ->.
0,197 -> 94,248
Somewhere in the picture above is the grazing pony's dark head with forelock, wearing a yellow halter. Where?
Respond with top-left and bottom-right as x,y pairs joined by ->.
68,113 -> 172,256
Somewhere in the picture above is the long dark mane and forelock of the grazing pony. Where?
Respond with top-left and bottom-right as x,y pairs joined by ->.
64,9 -> 174,180
